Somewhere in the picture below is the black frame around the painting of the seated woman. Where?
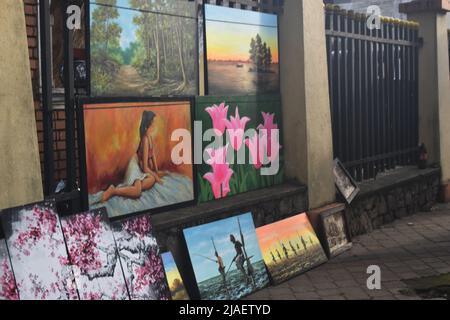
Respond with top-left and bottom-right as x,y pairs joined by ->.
76,96 -> 198,222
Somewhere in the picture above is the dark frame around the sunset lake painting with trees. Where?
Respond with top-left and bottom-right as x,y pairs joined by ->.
203,3 -> 281,96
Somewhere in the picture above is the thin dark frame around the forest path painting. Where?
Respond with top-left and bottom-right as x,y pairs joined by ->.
84,0 -> 200,99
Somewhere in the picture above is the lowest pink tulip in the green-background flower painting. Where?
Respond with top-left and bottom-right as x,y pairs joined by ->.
203,145 -> 234,199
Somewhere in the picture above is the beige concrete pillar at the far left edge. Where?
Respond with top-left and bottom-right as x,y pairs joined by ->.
0,0 -> 43,209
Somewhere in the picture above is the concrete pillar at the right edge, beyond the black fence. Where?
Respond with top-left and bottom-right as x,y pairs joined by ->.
409,12 -> 450,190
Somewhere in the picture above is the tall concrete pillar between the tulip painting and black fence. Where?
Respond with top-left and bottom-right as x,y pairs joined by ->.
280,0 -> 335,208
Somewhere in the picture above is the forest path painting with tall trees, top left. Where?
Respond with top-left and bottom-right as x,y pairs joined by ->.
89,0 -> 198,97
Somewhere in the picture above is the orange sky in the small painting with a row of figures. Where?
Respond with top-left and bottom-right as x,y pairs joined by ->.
256,213 -> 319,262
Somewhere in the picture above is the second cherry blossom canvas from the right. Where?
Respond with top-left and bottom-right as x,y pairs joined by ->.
61,209 -> 129,300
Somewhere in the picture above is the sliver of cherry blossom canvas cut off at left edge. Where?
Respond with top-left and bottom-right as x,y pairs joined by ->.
0,239 -> 19,300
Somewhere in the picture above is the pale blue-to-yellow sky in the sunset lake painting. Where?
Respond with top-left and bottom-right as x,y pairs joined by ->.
205,5 -> 278,63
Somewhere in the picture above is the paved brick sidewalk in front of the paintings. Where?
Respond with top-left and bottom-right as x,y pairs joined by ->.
248,206 -> 450,300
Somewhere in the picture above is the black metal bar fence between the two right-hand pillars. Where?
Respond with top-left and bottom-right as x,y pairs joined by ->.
325,5 -> 419,181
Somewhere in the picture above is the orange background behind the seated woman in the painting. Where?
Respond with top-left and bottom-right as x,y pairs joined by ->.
84,102 -> 193,194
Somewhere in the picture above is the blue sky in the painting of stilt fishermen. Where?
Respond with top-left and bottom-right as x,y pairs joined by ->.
184,213 -> 262,283
